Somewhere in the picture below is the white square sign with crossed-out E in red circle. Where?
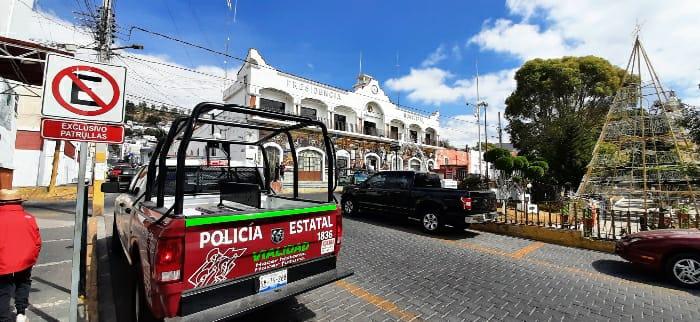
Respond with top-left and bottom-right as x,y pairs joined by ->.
41,55 -> 126,123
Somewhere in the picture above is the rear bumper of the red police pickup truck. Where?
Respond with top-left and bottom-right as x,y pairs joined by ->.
172,258 -> 353,321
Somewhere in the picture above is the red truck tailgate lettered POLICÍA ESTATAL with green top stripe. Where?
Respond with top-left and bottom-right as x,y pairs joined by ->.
183,204 -> 341,292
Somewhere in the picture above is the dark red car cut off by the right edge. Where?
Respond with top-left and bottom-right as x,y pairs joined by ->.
615,229 -> 700,288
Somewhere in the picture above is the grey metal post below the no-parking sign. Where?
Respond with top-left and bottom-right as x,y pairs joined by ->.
69,142 -> 88,322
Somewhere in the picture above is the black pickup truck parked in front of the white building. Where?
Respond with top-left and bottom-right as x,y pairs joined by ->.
341,171 -> 496,233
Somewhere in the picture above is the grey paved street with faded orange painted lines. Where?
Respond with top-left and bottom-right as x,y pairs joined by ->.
101,194 -> 700,321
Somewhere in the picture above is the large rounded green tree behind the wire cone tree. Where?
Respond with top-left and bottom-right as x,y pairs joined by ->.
505,56 -> 633,185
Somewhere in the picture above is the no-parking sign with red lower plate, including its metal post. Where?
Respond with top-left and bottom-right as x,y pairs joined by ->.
41,54 -> 126,322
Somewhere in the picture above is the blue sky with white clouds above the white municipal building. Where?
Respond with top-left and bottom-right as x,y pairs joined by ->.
20,0 -> 700,145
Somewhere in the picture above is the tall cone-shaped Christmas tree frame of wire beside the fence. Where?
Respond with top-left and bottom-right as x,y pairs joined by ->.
578,36 -> 700,214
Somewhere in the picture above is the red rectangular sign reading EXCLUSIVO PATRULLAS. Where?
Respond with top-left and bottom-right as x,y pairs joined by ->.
41,119 -> 124,144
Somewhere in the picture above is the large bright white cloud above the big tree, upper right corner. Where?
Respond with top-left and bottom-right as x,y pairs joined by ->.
470,0 -> 700,90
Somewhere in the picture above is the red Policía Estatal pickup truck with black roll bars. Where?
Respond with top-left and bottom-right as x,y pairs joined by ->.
103,103 -> 352,321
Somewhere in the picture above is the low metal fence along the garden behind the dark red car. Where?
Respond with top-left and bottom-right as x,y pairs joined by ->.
496,200 -> 700,240
